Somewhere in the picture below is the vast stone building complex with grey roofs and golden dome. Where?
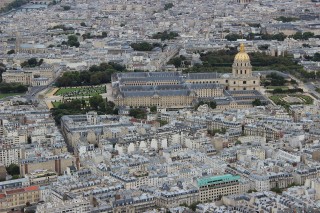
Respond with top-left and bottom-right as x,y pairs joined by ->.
112,44 -> 264,109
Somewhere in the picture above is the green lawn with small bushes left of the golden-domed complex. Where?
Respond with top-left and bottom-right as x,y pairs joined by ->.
55,86 -> 106,97
